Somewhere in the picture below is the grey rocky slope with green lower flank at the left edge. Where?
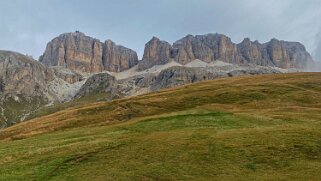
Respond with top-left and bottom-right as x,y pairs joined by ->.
0,51 -> 90,128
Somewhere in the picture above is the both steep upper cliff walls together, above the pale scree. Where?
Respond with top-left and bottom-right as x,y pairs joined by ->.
39,32 -> 312,73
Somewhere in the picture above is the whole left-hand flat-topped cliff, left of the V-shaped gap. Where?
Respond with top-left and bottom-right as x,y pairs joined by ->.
39,32 -> 138,73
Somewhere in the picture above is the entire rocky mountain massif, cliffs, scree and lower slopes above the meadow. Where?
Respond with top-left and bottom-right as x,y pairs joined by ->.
0,31 -> 313,127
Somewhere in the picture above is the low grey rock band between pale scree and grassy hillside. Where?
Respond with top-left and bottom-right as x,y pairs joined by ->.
76,64 -> 281,100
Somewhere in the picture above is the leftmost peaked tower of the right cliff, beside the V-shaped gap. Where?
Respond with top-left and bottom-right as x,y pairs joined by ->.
138,37 -> 172,71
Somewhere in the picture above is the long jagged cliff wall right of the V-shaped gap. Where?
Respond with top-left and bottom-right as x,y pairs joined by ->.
140,34 -> 312,70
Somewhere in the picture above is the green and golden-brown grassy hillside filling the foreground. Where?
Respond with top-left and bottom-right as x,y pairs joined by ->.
0,73 -> 321,180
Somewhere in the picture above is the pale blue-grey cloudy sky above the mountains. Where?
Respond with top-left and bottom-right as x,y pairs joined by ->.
0,0 -> 321,60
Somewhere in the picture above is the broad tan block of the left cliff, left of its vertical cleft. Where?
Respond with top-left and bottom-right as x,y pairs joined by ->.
39,32 -> 103,72
